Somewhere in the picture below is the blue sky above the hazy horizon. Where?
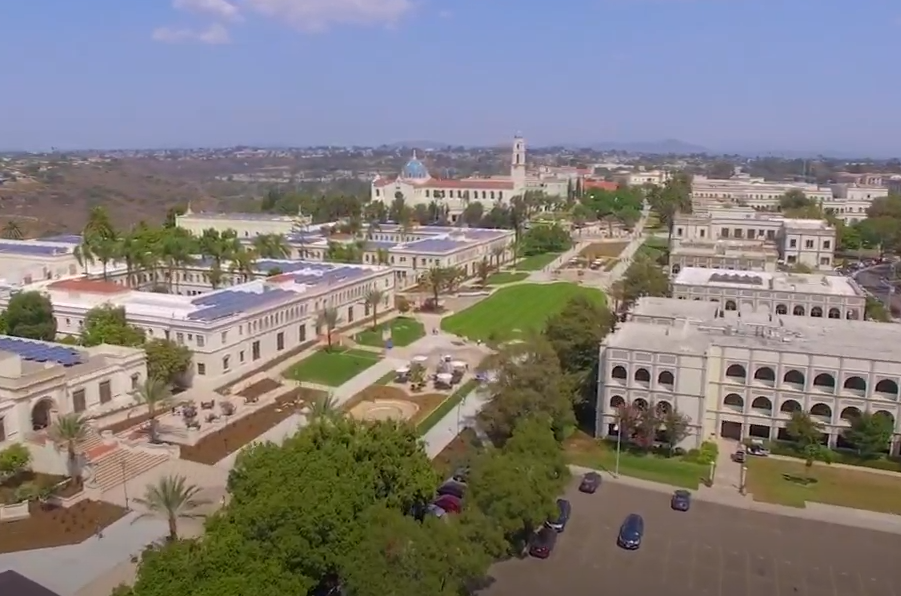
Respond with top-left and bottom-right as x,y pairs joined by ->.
0,0 -> 901,155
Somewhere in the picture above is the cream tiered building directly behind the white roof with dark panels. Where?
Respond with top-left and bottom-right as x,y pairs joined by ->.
670,207 -> 835,273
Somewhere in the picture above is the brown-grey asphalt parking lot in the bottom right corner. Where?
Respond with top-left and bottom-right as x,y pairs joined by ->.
482,483 -> 901,596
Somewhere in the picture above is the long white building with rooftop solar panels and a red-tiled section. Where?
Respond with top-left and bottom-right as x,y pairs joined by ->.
0,261 -> 395,386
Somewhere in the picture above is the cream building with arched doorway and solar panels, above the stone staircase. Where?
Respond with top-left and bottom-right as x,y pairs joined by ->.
0,335 -> 147,449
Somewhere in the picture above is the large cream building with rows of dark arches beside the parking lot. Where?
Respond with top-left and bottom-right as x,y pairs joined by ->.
596,298 -> 901,454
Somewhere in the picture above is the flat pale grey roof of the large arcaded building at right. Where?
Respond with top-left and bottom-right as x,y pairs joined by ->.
604,298 -> 901,361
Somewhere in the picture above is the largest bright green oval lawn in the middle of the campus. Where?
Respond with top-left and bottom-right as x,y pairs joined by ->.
441,283 -> 606,341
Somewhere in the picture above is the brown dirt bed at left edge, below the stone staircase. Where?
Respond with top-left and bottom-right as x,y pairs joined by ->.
0,499 -> 128,553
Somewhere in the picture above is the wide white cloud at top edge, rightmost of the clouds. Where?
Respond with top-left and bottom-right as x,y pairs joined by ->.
245,0 -> 414,31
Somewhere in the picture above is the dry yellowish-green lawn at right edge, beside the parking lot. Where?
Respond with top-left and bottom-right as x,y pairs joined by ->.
747,457 -> 901,515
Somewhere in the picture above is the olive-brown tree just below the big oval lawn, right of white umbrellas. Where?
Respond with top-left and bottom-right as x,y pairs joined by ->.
479,336 -> 574,442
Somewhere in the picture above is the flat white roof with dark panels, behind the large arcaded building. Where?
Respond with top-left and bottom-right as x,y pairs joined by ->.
673,267 -> 863,296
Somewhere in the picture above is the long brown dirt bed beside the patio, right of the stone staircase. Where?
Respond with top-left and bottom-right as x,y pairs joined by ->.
181,387 -> 325,465
